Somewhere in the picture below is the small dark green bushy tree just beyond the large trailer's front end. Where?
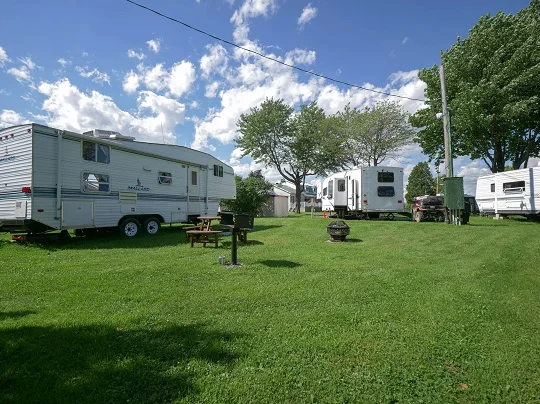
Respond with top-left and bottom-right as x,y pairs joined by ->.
221,172 -> 273,215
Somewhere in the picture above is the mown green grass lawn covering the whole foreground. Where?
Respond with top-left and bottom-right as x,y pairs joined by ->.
0,215 -> 540,403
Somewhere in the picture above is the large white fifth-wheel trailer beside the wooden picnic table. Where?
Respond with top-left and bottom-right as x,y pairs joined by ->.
0,124 -> 236,236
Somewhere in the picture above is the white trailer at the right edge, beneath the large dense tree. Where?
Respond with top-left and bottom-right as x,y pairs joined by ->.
476,167 -> 540,217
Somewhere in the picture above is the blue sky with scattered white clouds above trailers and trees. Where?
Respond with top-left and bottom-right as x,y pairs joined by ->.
0,0 -> 529,192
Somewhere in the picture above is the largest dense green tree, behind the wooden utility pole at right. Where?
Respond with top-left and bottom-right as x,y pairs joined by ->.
410,0 -> 540,172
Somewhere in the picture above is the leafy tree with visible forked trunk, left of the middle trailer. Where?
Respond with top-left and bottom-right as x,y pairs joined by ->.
237,99 -> 341,213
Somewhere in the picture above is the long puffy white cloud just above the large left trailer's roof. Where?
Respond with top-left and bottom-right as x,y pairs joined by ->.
38,78 -> 185,143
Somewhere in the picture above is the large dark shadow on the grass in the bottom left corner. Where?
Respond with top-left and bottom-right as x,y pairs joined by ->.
0,324 -> 239,403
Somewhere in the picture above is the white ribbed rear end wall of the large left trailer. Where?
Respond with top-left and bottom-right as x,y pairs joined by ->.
0,125 -> 32,219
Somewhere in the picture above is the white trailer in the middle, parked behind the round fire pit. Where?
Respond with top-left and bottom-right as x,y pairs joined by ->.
317,166 -> 405,218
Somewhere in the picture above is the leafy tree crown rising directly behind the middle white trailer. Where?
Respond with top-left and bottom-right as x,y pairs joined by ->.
337,101 -> 414,166
